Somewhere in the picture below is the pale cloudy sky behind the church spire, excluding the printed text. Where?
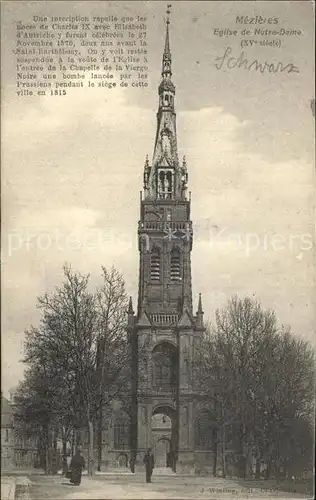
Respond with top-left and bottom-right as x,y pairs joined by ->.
1,1 -> 315,394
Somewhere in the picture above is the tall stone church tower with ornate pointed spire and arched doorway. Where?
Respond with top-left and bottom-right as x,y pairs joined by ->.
129,11 -> 204,470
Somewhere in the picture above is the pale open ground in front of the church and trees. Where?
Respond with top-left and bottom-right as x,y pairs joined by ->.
6,474 -> 312,500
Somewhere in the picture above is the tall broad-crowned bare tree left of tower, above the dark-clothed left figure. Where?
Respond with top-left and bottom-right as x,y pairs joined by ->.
21,266 -> 97,472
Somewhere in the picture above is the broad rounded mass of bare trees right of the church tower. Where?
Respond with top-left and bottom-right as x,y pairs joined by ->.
196,297 -> 314,477
